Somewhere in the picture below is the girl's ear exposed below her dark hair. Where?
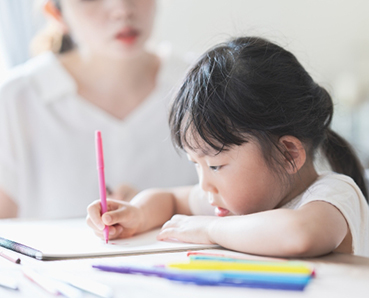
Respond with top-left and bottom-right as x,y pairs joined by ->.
279,136 -> 306,174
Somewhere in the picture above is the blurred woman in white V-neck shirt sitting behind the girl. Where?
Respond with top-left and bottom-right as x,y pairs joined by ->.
0,0 -> 196,218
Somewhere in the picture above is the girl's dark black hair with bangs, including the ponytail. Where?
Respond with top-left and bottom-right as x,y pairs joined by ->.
169,37 -> 368,198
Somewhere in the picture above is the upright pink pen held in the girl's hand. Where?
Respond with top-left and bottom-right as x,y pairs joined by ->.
95,130 -> 109,243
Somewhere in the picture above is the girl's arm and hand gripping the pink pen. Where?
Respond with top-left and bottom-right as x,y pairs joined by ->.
86,186 -> 192,239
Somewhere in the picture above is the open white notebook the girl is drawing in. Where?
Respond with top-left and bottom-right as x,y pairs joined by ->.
0,219 -> 219,260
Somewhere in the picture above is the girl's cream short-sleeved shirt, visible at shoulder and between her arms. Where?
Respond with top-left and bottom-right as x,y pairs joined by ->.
189,172 -> 369,257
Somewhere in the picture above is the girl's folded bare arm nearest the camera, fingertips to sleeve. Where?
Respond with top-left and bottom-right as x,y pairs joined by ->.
160,201 -> 349,257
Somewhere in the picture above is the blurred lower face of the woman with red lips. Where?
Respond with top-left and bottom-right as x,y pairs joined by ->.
61,0 -> 156,57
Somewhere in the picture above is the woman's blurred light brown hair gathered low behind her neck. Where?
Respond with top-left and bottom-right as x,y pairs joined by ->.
31,0 -> 75,55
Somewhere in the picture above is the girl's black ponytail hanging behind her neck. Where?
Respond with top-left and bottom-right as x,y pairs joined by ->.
322,128 -> 368,201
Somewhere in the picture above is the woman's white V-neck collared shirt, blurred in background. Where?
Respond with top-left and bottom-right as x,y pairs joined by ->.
0,52 -> 197,218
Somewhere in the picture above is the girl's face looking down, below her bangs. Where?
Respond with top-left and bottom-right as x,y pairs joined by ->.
185,141 -> 285,216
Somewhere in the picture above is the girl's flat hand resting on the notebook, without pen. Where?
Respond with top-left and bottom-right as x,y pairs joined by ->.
157,215 -> 218,244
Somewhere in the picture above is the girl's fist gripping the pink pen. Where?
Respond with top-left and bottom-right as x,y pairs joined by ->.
86,199 -> 144,239
